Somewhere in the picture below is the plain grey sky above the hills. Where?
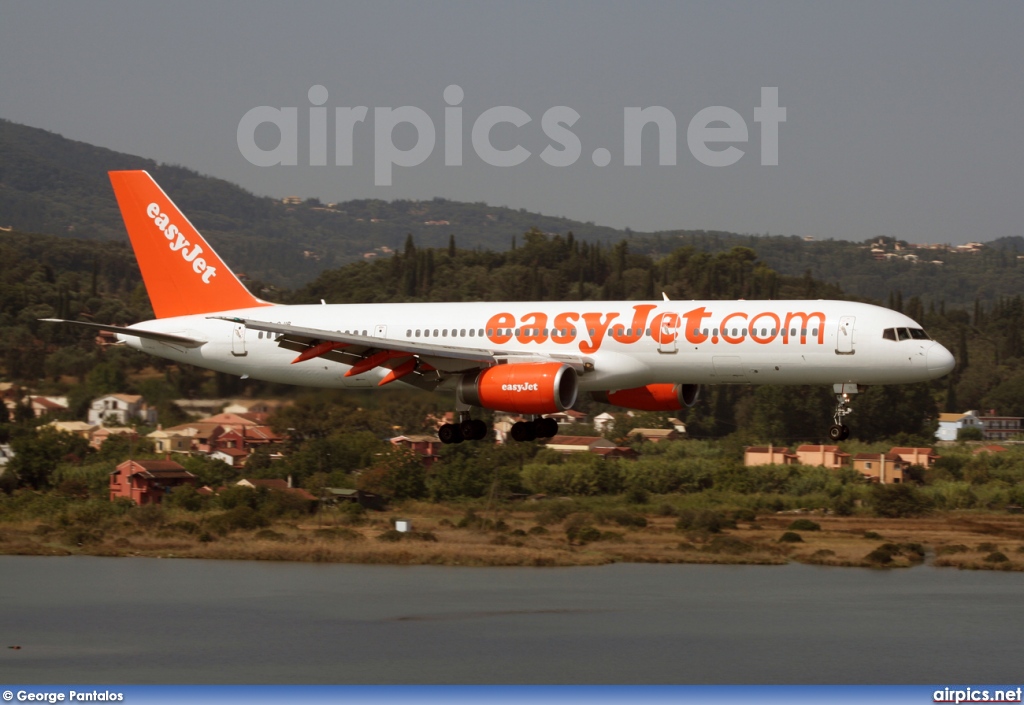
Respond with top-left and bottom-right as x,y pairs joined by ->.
0,0 -> 1024,244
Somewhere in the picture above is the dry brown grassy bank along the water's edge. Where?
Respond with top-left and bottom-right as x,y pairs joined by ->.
0,500 -> 1024,571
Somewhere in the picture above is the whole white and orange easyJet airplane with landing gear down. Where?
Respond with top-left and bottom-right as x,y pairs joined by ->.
44,171 -> 954,443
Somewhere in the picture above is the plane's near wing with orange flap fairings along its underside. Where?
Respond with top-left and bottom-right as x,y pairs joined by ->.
210,316 -> 593,388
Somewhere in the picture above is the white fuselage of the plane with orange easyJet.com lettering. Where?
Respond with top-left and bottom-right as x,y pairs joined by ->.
121,300 -> 953,391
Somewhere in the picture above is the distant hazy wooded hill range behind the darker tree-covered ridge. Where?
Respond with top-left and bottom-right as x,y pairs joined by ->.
0,120 -> 1024,308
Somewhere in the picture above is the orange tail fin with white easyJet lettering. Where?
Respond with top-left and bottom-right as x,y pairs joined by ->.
110,171 -> 270,319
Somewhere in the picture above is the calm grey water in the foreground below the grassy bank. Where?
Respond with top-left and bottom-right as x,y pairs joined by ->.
0,556 -> 1024,683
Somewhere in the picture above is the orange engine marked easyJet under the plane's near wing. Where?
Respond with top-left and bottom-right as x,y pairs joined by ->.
458,363 -> 579,414
